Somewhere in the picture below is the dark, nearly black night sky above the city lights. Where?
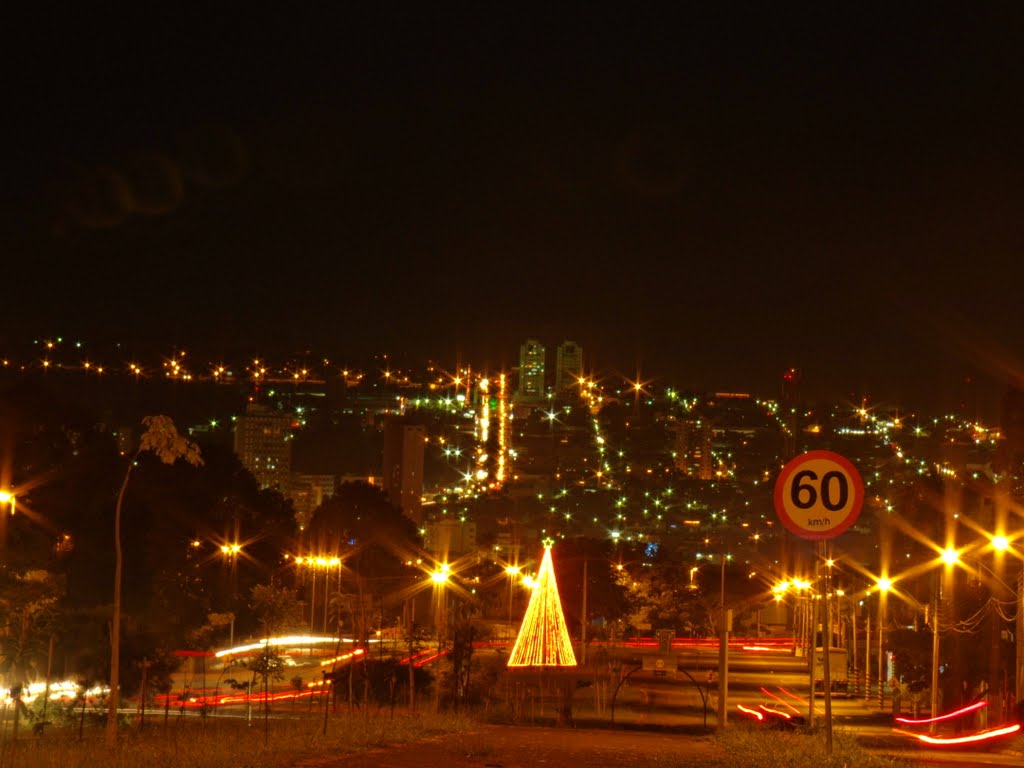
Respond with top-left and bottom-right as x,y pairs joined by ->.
0,2 -> 1024,415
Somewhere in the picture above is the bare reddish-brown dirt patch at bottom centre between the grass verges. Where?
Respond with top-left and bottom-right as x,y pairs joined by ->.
303,725 -> 726,768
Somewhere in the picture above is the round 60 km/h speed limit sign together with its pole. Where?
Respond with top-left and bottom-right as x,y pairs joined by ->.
774,451 -> 864,755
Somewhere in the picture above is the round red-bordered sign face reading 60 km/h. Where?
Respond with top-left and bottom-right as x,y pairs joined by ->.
775,451 -> 864,539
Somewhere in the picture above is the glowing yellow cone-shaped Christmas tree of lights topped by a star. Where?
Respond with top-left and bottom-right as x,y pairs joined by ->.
508,544 -> 575,667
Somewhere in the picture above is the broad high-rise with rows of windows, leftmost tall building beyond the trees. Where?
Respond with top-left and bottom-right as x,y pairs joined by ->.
234,402 -> 292,495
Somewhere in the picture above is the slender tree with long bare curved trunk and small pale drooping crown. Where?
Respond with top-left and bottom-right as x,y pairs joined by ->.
106,416 -> 203,745
